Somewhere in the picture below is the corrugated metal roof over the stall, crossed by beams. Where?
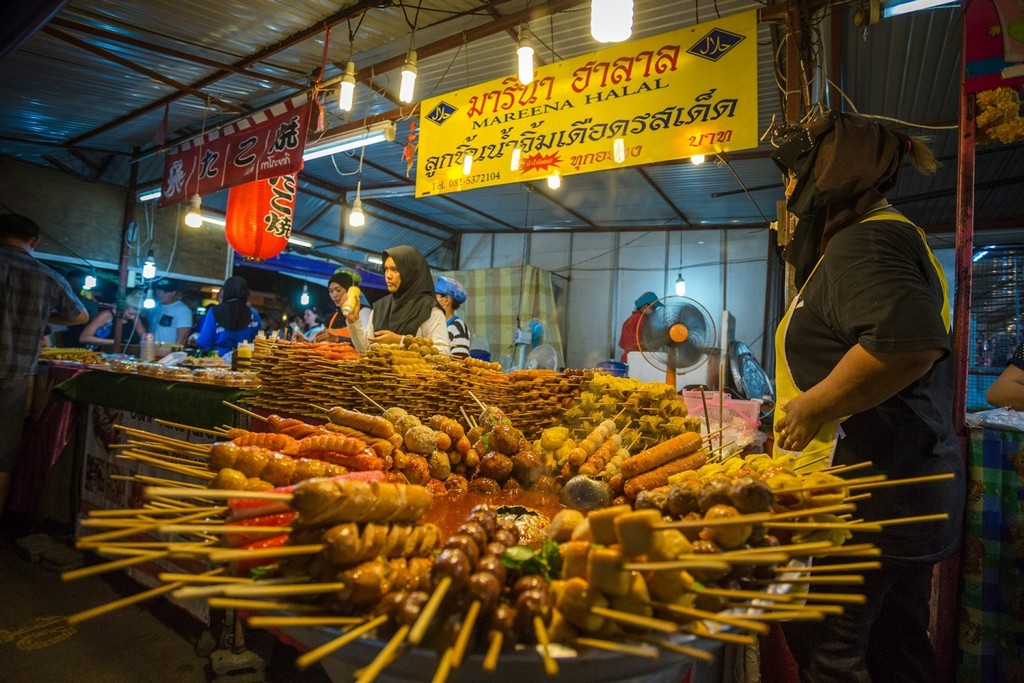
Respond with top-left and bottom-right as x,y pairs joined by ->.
0,0 -> 1024,270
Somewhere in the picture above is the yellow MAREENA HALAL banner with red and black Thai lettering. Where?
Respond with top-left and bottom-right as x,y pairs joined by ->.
416,10 -> 758,197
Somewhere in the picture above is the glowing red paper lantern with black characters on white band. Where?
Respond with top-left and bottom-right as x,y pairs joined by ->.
224,174 -> 296,261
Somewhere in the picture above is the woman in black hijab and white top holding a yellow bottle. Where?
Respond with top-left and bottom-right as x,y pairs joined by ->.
345,246 -> 449,353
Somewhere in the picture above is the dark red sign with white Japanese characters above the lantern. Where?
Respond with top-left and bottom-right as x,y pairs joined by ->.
160,94 -> 310,207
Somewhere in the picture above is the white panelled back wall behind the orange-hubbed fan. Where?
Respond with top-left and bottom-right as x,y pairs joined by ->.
459,229 -> 769,368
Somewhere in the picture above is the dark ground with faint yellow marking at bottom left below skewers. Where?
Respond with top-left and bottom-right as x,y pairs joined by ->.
0,540 -> 329,683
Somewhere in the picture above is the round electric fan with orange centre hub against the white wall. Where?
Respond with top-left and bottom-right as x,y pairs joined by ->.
637,296 -> 717,389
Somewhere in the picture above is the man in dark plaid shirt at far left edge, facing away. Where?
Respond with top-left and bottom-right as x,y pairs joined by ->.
0,213 -> 89,524
